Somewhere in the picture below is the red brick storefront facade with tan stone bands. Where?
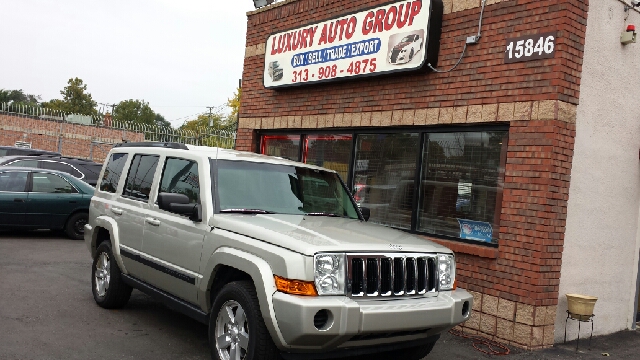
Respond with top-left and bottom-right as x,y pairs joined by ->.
236,0 -> 635,349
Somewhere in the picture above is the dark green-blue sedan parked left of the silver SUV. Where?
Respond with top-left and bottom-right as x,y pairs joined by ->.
0,167 -> 95,240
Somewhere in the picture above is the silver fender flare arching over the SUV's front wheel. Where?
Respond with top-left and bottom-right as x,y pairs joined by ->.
199,247 -> 289,348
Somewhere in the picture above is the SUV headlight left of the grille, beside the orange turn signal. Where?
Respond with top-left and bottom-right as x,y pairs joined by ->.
313,254 -> 346,295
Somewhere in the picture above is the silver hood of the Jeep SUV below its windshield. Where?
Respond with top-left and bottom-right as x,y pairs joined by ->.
212,214 -> 452,256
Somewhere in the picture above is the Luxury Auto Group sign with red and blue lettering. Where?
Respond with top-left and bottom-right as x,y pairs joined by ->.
264,0 -> 442,88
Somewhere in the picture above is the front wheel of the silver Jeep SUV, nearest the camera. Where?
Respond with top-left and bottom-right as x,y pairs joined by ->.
209,281 -> 282,360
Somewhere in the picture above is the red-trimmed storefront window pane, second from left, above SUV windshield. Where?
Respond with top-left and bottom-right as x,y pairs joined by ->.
302,135 -> 353,181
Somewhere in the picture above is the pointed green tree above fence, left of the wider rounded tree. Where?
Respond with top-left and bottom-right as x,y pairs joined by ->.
42,78 -> 98,115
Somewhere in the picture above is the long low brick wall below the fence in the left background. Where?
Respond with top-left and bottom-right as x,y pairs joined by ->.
0,114 -> 144,162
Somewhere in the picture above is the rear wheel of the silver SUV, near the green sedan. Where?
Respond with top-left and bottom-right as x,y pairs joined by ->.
91,241 -> 133,309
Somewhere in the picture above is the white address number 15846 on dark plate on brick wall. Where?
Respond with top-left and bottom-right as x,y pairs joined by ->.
504,32 -> 556,64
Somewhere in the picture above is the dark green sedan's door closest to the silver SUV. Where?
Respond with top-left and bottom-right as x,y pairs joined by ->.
25,171 -> 82,229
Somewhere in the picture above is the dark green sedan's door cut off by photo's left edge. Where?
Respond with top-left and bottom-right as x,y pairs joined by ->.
0,170 -> 29,226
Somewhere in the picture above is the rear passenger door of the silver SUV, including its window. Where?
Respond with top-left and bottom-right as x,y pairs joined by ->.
111,154 -> 160,281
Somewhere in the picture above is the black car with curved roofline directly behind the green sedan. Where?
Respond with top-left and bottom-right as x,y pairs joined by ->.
0,155 -> 102,187
